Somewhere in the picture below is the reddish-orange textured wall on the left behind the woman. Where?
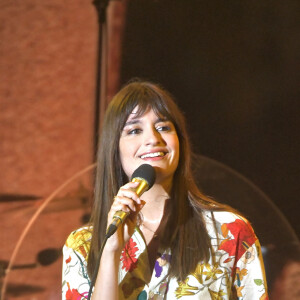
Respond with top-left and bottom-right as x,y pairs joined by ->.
0,0 -> 124,299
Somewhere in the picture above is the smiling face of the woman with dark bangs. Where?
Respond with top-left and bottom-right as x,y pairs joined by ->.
119,108 -> 179,183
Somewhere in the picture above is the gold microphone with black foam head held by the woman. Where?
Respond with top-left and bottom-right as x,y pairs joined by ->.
106,164 -> 156,238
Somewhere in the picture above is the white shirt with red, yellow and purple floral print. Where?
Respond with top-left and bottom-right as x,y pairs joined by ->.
62,212 -> 268,300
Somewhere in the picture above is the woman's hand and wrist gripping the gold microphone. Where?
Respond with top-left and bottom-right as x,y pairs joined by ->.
105,182 -> 144,252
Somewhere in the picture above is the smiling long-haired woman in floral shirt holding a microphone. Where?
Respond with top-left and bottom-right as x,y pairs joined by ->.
63,81 -> 268,300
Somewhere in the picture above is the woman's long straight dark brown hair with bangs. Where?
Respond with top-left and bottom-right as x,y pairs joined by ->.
88,81 -> 233,280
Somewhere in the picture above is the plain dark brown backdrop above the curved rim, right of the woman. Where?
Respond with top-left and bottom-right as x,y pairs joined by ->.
121,0 -> 300,235
